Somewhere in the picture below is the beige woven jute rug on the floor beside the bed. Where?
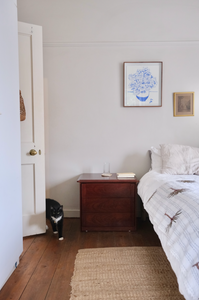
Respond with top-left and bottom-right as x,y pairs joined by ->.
70,247 -> 184,300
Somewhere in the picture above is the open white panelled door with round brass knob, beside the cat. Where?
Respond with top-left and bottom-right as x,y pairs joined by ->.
18,22 -> 46,236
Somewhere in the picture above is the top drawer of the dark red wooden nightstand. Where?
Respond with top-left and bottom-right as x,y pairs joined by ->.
82,182 -> 135,199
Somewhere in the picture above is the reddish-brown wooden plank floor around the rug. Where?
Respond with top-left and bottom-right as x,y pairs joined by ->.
0,219 -> 160,300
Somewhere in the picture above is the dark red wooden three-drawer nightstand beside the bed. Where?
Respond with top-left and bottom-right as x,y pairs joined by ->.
77,173 -> 138,231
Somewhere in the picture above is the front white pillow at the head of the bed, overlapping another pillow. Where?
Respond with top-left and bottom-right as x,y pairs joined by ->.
160,144 -> 199,175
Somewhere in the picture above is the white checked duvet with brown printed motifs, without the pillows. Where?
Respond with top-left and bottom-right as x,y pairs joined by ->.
138,170 -> 199,300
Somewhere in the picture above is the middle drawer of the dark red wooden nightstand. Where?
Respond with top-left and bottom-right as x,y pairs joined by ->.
82,197 -> 134,213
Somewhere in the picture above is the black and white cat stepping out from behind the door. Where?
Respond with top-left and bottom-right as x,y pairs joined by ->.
46,198 -> 64,240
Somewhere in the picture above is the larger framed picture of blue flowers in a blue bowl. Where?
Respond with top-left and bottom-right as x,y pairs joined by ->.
123,61 -> 163,107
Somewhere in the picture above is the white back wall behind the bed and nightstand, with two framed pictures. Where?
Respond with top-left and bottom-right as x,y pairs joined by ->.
18,0 -> 199,216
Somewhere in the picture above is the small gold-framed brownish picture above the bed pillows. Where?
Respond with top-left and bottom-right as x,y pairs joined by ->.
173,92 -> 194,117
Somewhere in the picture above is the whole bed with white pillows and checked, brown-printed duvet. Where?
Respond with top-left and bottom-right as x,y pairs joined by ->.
138,144 -> 199,300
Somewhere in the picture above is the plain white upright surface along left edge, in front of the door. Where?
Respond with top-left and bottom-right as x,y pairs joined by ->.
0,0 -> 23,289
